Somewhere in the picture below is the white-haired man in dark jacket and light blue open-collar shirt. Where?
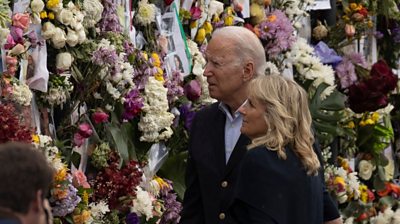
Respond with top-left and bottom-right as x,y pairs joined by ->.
180,27 -> 341,224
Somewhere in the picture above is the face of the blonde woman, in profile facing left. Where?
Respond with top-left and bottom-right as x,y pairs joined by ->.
239,98 -> 268,139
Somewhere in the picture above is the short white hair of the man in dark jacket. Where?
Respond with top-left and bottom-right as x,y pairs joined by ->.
212,26 -> 266,77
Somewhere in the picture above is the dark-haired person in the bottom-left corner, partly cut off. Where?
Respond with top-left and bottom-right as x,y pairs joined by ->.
0,143 -> 53,224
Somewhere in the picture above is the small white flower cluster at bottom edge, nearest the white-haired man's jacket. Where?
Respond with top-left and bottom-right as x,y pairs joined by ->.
131,186 -> 153,221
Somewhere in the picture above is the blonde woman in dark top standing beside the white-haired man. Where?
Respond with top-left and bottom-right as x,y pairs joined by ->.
232,75 -> 334,224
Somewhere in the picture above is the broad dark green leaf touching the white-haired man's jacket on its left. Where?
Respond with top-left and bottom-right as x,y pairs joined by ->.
158,151 -> 187,199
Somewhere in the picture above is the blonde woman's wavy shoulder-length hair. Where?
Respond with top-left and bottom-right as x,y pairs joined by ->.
248,75 -> 320,175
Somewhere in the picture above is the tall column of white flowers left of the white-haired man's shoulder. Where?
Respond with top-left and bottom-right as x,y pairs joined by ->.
139,77 -> 174,142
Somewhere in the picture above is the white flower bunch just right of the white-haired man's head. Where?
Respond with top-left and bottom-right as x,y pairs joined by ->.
286,37 -> 336,99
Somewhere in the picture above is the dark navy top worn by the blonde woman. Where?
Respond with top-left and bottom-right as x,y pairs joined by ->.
231,146 -> 324,224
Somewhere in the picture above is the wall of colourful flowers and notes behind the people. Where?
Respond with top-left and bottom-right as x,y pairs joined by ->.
0,0 -> 400,223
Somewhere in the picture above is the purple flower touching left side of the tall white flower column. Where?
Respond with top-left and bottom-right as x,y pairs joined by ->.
122,89 -> 144,120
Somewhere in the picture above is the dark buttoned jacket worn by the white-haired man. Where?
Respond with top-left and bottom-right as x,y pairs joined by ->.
180,103 -> 339,224
